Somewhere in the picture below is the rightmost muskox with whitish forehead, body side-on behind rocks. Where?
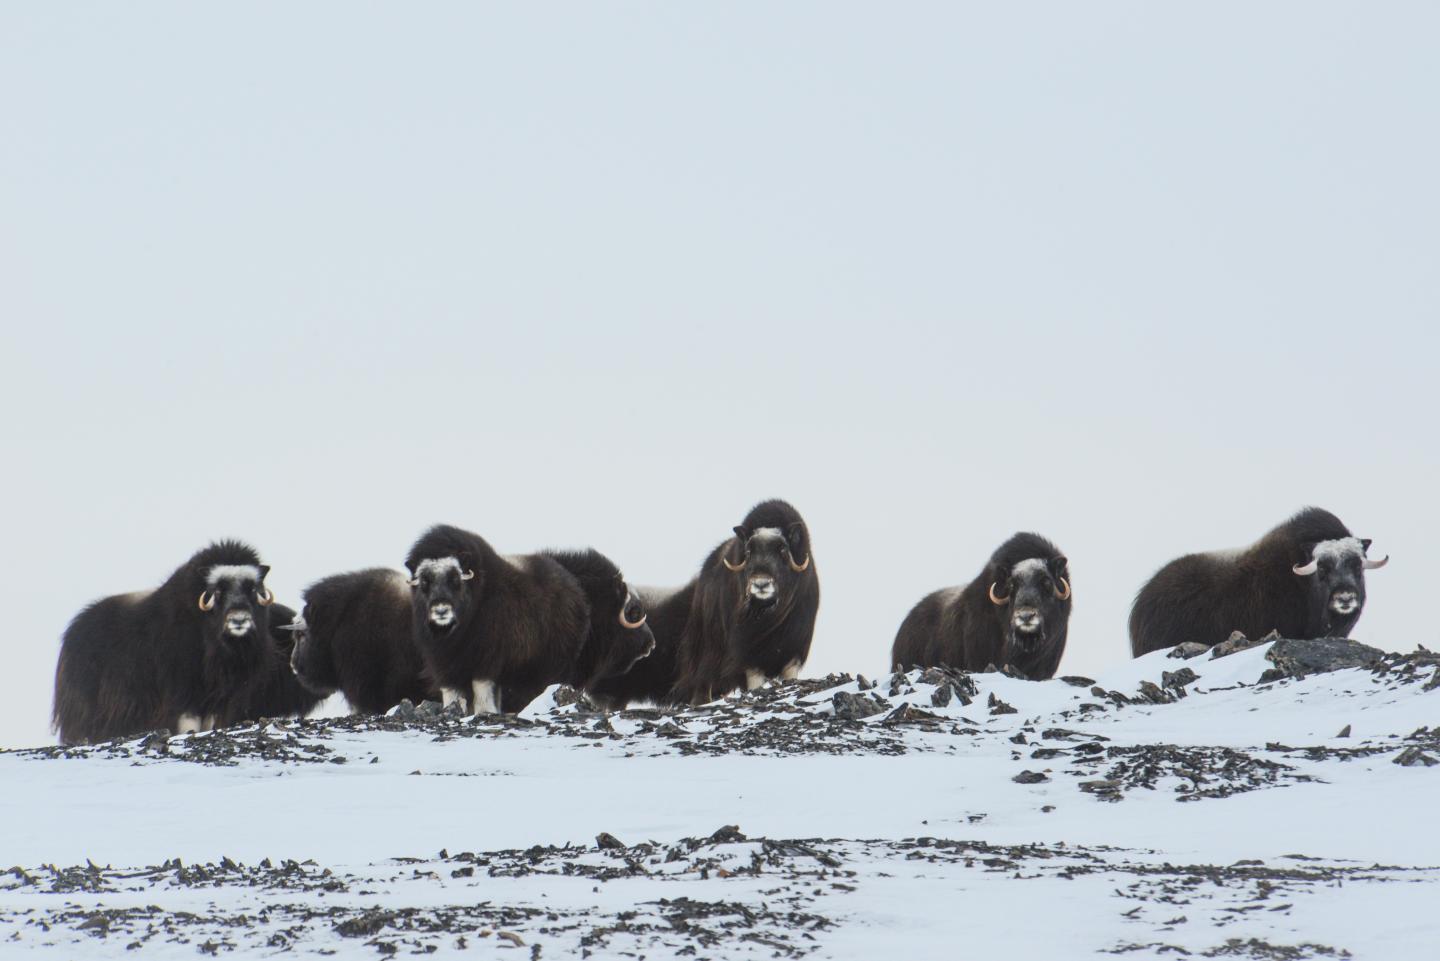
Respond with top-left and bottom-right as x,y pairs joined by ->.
1130,507 -> 1390,657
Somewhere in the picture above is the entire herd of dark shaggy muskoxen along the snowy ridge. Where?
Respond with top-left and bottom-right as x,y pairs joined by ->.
53,500 -> 1388,743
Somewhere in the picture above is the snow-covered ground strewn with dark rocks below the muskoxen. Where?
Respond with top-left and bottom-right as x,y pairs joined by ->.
0,641 -> 1440,961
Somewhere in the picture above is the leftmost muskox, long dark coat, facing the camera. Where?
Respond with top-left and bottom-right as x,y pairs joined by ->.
53,540 -> 274,743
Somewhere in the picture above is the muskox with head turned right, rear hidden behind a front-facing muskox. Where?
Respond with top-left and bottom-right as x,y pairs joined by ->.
541,550 -> 655,703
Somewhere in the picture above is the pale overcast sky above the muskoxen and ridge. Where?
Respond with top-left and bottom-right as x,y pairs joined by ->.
0,1 -> 1440,745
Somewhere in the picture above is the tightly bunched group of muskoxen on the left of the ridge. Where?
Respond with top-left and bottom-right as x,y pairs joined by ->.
53,500 -> 819,743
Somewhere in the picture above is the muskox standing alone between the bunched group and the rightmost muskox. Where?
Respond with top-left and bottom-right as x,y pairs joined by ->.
890,533 -> 1070,680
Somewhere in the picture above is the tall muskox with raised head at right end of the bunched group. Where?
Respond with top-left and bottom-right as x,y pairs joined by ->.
655,500 -> 819,705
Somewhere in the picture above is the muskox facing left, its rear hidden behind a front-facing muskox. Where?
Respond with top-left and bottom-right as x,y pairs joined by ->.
291,568 -> 438,715
